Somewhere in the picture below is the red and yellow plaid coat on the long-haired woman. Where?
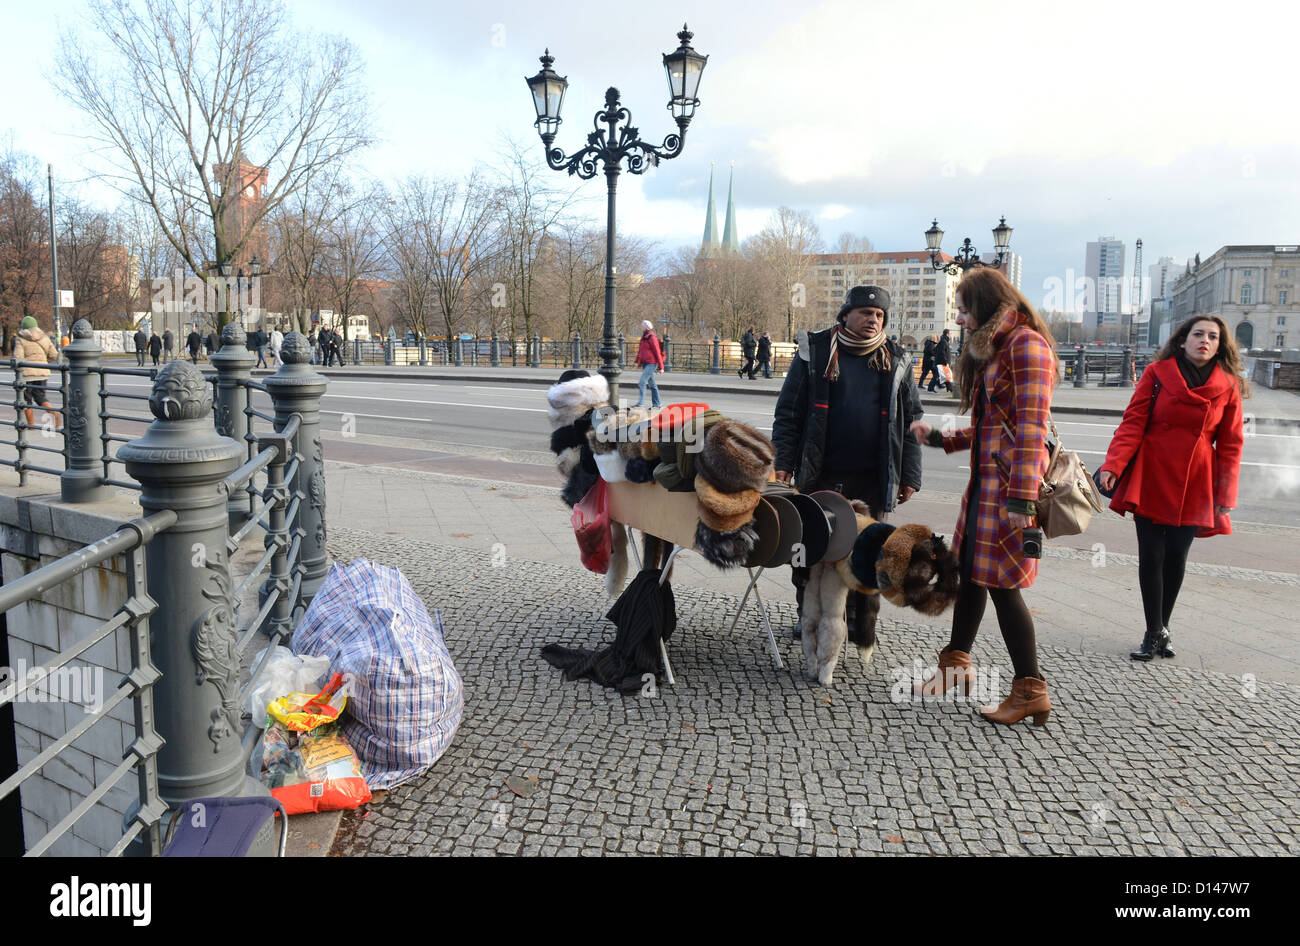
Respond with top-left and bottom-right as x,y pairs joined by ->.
944,313 -> 1056,589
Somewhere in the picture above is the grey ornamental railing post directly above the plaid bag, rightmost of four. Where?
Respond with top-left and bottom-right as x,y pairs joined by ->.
264,331 -> 329,597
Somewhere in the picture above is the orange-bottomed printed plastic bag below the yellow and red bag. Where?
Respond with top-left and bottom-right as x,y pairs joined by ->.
261,722 -> 371,815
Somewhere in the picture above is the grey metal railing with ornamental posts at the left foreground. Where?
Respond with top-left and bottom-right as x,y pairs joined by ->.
0,322 -> 329,854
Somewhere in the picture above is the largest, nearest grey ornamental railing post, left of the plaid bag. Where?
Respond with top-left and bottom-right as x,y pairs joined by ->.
117,361 -> 274,842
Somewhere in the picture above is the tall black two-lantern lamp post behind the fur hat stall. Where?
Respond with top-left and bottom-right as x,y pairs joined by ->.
527,23 -> 709,405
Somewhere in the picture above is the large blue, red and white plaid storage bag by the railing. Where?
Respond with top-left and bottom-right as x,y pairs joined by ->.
293,559 -> 465,789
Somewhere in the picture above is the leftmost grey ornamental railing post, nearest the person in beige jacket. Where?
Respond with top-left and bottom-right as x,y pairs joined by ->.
59,318 -> 113,503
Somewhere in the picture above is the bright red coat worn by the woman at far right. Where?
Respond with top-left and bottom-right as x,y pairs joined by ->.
1101,359 -> 1243,537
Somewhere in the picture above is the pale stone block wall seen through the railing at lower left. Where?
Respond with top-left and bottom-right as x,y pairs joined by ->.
0,472 -> 140,856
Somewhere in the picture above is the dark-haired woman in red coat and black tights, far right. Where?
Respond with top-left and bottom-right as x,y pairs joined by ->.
1097,316 -> 1249,660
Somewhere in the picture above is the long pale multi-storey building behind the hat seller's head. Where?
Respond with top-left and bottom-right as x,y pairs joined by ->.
798,249 -> 961,348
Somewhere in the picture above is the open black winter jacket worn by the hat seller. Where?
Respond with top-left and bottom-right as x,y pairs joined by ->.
772,329 -> 924,512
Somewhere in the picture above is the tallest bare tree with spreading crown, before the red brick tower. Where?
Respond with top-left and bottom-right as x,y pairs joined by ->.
55,0 -> 369,328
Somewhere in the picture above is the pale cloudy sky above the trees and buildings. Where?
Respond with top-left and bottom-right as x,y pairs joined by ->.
0,0 -> 1300,318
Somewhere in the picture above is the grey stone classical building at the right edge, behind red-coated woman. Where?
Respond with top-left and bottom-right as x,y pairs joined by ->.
1170,244 -> 1300,350
